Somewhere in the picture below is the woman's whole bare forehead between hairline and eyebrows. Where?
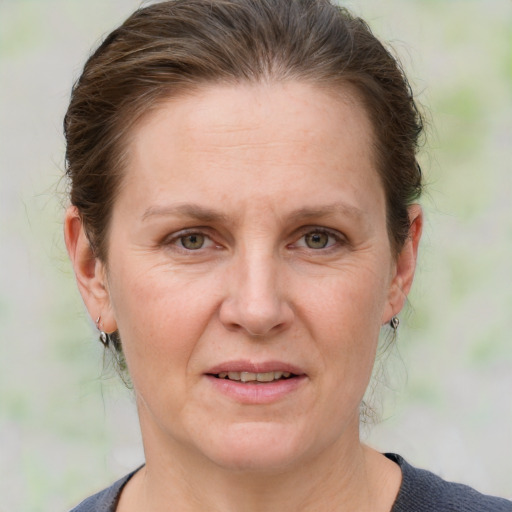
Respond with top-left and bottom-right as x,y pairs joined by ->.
120,82 -> 383,220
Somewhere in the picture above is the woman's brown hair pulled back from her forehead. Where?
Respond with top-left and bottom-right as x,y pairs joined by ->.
64,0 -> 423,368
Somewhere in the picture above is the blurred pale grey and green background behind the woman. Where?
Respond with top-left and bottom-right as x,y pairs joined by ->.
0,0 -> 512,512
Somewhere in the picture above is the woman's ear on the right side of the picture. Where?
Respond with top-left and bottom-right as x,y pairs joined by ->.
382,204 -> 423,324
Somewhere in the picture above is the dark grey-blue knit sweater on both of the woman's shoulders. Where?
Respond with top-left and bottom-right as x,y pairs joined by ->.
70,453 -> 512,512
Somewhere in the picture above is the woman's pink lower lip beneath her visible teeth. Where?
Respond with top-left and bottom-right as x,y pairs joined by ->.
206,375 -> 306,404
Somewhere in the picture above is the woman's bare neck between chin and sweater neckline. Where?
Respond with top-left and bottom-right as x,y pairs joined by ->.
118,414 -> 401,512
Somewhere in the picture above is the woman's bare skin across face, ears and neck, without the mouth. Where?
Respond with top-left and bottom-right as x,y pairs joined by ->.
65,82 -> 422,511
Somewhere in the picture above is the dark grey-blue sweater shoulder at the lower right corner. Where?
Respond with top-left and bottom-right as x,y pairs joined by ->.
386,453 -> 512,512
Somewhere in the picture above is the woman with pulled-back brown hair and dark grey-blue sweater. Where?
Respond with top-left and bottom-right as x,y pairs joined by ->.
65,0 -> 512,512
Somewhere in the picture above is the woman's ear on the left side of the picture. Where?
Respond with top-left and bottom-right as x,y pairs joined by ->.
64,206 -> 117,333
